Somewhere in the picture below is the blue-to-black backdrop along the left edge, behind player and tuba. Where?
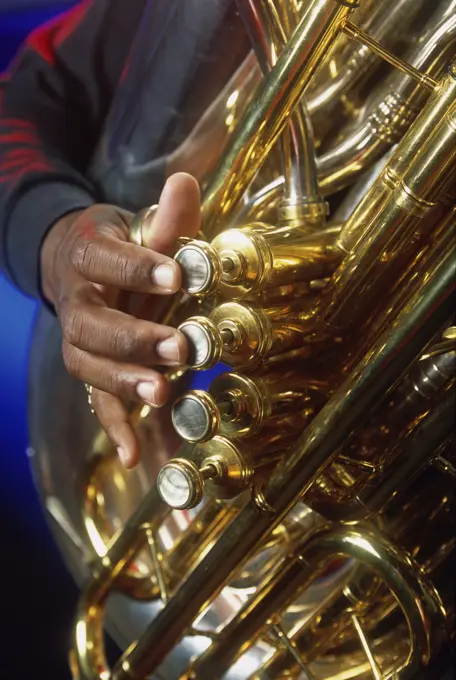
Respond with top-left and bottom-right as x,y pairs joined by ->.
0,0 -> 77,680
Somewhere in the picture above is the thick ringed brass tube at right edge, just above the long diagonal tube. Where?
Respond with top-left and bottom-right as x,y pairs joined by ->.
317,66 -> 456,329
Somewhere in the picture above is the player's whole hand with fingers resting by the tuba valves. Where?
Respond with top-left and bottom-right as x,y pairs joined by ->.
41,173 -> 201,467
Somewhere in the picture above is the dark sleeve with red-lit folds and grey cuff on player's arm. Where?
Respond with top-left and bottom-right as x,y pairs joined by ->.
0,0 -> 143,297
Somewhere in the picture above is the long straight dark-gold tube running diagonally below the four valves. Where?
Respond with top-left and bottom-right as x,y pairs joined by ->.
105,236 -> 456,680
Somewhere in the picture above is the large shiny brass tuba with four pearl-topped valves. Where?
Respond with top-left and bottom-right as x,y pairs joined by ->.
30,0 -> 456,680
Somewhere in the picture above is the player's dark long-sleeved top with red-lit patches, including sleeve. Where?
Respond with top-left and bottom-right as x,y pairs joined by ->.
0,0 -> 247,298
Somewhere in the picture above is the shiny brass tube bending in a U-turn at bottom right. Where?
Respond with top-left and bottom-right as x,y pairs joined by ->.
184,528 -> 446,680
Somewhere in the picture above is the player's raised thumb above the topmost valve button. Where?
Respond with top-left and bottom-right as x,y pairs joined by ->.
142,172 -> 201,254
